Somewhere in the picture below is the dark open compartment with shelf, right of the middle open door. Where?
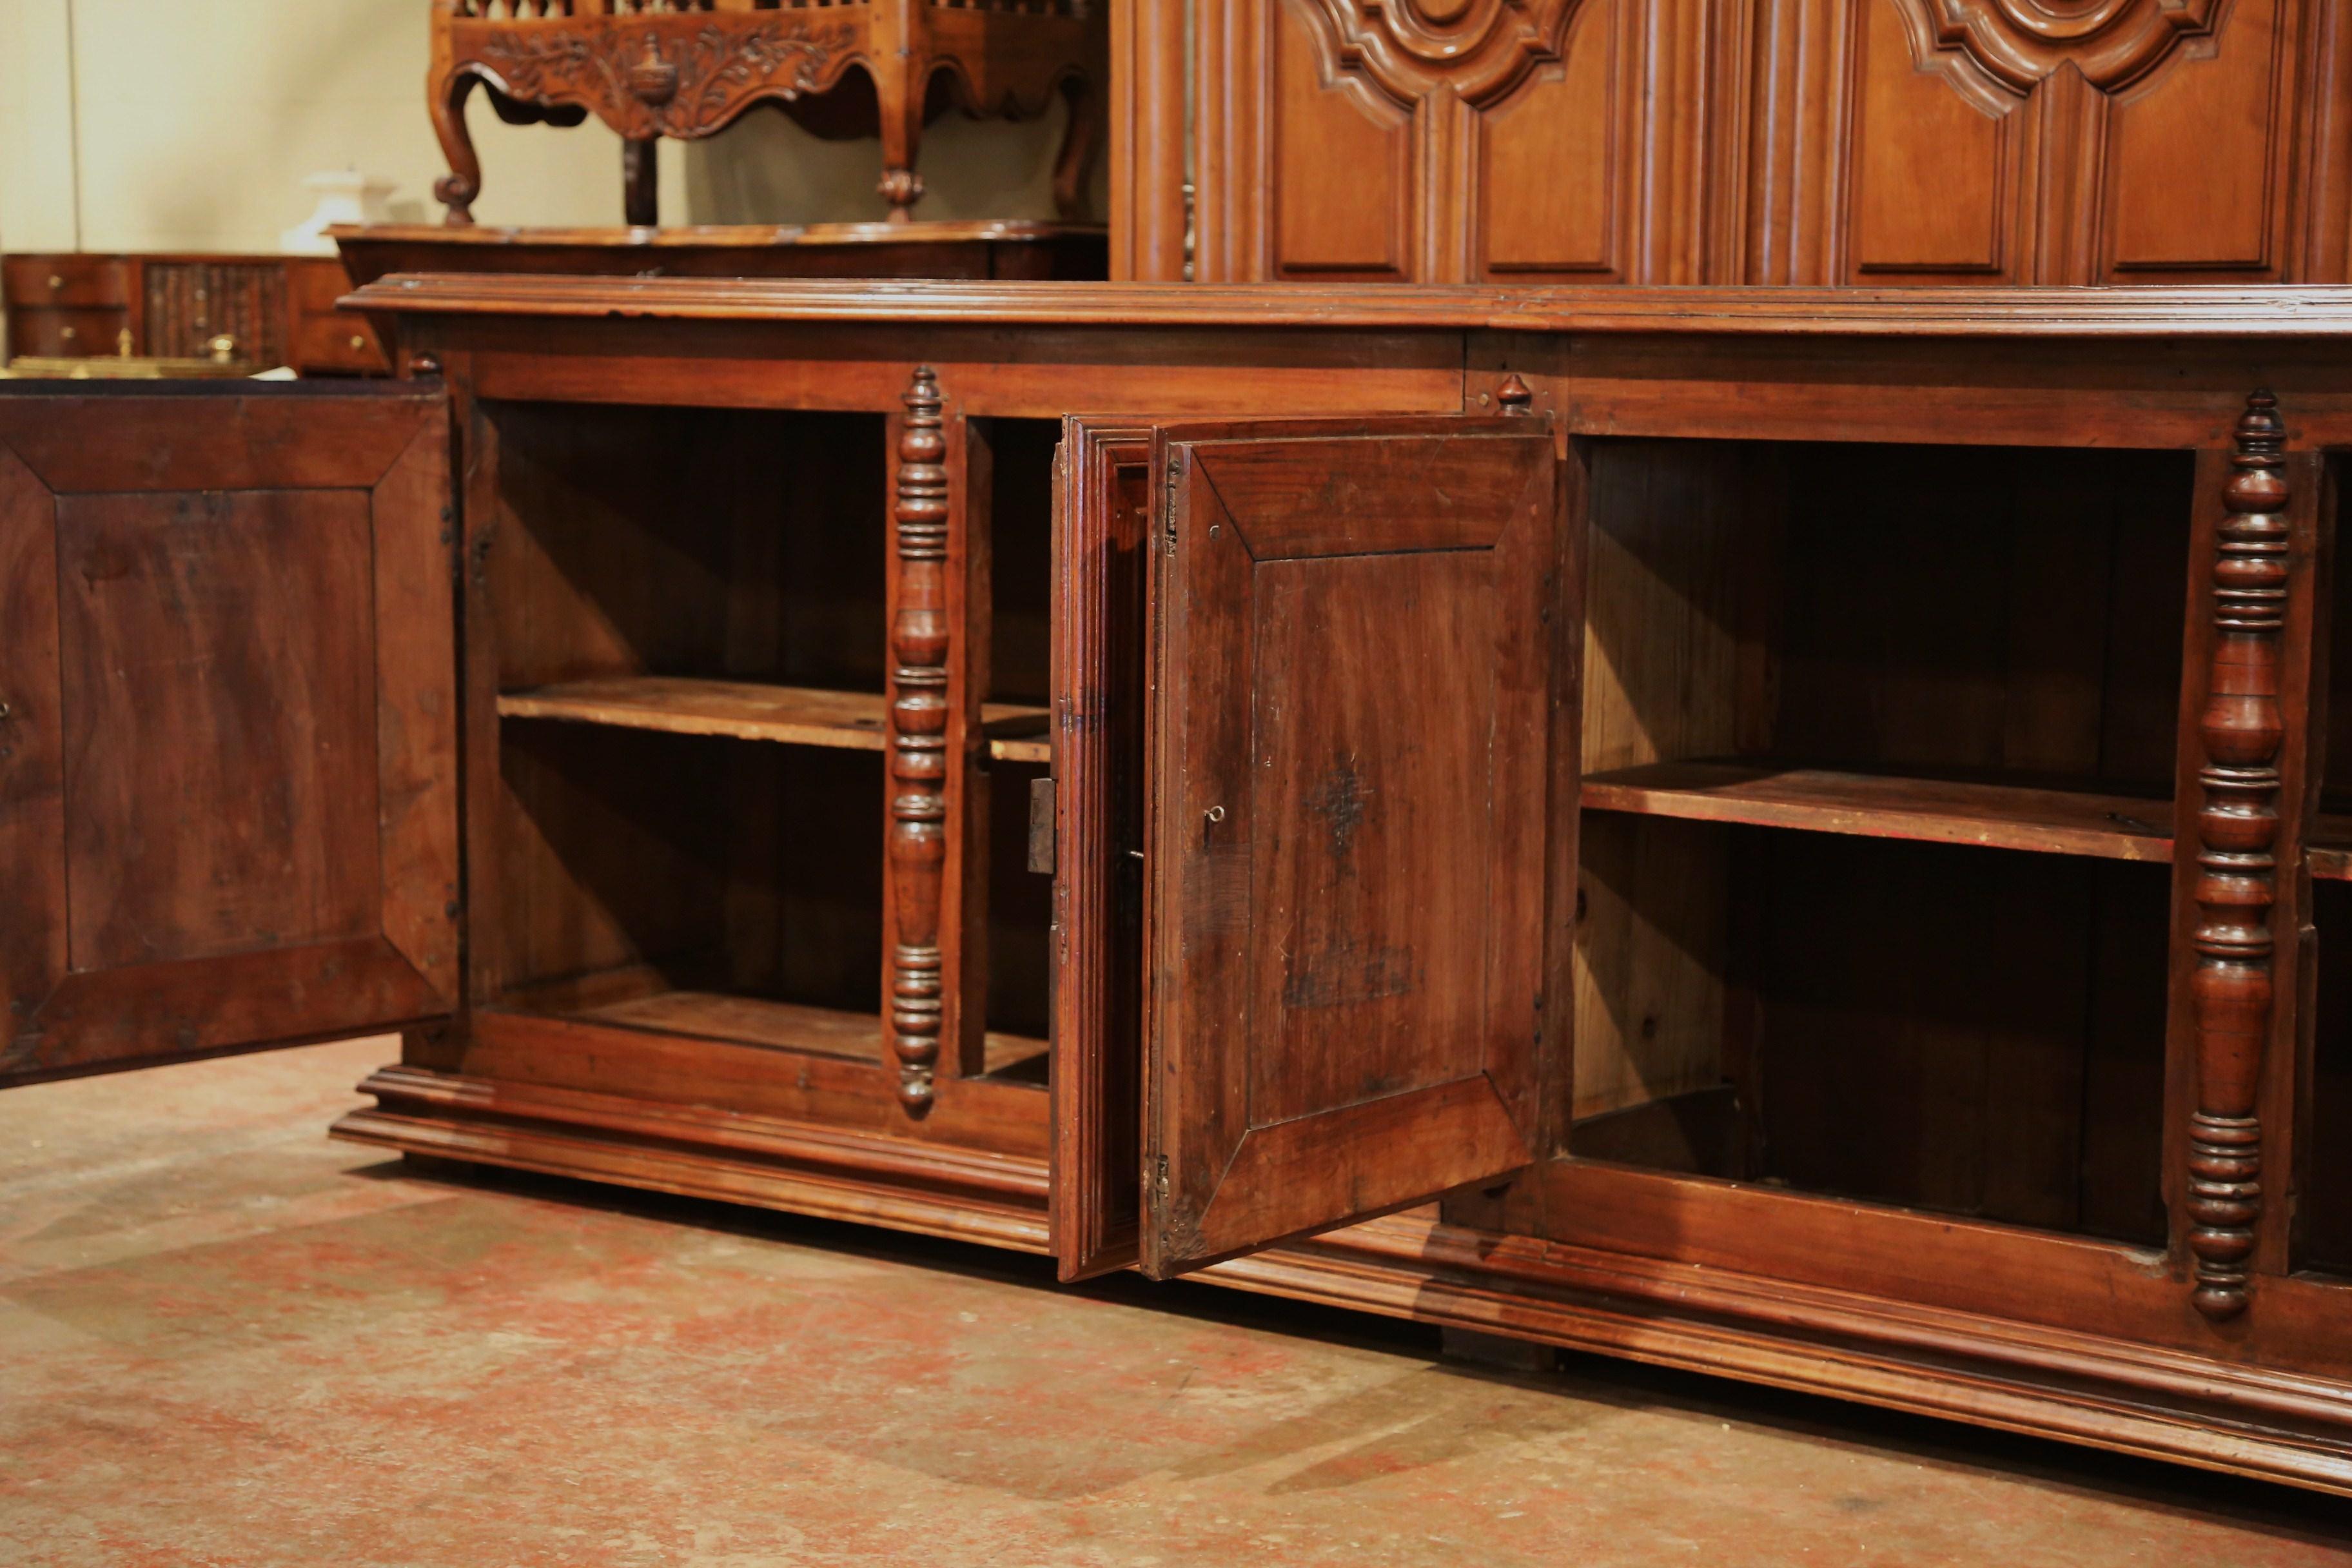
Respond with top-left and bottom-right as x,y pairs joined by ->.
1569,442 -> 2192,1244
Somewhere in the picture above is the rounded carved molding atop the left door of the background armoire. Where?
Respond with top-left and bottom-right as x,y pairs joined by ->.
1273,0 -> 1580,108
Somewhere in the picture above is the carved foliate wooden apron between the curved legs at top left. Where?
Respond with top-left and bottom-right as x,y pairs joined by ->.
451,7 -> 861,141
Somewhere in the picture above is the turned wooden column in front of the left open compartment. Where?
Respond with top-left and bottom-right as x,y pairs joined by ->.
889,367 -> 948,1117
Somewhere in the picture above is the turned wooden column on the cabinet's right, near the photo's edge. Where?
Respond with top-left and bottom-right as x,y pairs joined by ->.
2188,393 -> 2293,1321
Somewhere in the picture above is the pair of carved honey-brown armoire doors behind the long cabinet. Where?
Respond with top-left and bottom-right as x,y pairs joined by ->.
1176,0 -> 2352,287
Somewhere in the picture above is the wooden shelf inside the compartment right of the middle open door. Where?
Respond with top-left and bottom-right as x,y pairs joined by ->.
1583,761 -> 2164,874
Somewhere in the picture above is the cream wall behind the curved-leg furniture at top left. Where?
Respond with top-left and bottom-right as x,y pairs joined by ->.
0,0 -> 1061,251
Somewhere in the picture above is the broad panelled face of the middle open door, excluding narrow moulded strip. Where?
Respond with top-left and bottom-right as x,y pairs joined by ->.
1141,421 -> 1560,1277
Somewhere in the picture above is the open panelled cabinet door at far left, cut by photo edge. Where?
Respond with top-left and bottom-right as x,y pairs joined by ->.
0,381 -> 458,1084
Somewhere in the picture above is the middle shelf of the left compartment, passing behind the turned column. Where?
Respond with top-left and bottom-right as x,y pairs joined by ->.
498,674 -> 1052,761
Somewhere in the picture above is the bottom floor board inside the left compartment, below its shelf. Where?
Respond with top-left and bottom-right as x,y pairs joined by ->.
504,964 -> 1046,1081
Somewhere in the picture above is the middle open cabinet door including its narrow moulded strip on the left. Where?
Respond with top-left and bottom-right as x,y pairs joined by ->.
1054,416 -> 1569,1277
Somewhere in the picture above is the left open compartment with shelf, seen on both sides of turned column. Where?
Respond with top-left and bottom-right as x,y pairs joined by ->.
475,404 -> 1052,1081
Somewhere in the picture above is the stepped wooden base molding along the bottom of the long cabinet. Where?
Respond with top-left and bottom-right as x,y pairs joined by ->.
334,1067 -> 2352,1495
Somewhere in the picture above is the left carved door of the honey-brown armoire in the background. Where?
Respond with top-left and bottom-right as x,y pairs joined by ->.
1193,0 -> 1738,282
